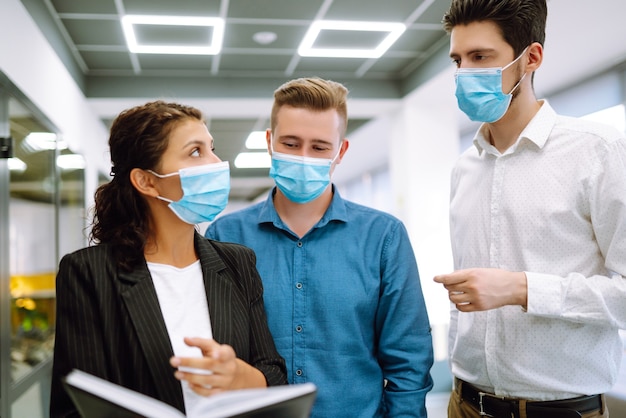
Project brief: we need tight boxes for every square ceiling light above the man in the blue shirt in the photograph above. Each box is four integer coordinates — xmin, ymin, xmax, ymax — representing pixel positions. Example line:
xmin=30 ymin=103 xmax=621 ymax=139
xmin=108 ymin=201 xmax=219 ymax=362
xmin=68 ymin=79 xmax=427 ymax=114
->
xmin=298 ymin=20 xmax=406 ymax=58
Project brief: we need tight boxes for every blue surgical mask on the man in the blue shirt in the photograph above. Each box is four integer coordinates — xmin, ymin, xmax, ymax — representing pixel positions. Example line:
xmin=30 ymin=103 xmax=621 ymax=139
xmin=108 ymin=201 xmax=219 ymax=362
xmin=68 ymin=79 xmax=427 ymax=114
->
xmin=270 ymin=142 xmax=339 ymax=204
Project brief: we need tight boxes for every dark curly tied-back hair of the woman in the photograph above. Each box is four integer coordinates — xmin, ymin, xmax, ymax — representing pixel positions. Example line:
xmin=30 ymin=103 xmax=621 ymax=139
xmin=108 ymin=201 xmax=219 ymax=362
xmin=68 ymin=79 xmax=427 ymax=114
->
xmin=89 ymin=100 xmax=203 ymax=271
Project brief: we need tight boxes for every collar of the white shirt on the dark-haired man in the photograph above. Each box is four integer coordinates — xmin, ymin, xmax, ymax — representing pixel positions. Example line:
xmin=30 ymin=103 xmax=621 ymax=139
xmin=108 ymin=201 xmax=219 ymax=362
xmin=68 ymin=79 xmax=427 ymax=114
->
xmin=474 ymin=99 xmax=557 ymax=155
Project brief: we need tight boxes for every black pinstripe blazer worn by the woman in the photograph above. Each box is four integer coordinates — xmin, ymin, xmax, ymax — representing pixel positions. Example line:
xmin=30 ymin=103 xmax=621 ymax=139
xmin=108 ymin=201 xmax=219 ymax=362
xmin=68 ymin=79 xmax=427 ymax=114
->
xmin=50 ymin=233 xmax=287 ymax=417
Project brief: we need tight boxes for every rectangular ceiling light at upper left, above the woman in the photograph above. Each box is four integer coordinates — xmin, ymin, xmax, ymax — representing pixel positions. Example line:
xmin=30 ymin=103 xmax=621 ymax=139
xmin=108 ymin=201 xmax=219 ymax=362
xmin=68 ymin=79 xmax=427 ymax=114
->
xmin=122 ymin=15 xmax=224 ymax=55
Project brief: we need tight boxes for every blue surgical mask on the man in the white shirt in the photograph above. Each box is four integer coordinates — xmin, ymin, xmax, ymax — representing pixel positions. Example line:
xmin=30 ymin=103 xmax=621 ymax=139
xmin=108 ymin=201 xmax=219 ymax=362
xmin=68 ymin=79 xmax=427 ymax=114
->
xmin=455 ymin=48 xmax=528 ymax=123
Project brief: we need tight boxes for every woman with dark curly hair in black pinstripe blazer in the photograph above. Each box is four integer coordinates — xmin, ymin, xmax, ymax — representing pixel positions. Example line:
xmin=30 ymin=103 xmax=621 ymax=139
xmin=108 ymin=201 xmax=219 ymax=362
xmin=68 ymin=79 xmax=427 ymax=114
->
xmin=50 ymin=101 xmax=286 ymax=417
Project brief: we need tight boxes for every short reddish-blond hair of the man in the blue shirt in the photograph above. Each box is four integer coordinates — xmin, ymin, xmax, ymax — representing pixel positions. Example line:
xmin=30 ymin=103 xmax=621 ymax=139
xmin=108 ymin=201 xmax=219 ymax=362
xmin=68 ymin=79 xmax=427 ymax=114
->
xmin=270 ymin=77 xmax=348 ymax=139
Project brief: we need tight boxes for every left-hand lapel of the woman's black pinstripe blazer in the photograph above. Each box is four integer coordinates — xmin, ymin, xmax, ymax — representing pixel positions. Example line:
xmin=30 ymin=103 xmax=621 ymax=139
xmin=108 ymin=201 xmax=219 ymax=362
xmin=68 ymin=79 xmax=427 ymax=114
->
xmin=119 ymin=263 xmax=183 ymax=407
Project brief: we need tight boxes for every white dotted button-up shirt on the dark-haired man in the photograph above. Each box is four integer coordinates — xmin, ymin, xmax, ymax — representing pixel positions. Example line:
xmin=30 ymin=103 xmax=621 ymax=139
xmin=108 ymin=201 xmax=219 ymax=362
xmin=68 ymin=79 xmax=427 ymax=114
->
xmin=449 ymin=101 xmax=626 ymax=400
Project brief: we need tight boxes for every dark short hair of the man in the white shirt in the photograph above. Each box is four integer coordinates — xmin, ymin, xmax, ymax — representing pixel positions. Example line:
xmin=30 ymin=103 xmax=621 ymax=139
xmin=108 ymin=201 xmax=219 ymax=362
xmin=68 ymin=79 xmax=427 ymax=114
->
xmin=442 ymin=0 xmax=548 ymax=56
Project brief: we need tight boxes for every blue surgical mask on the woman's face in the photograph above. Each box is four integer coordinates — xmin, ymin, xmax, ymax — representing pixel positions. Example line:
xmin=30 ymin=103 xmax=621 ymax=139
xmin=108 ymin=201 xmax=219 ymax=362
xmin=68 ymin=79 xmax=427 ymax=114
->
xmin=148 ymin=161 xmax=230 ymax=224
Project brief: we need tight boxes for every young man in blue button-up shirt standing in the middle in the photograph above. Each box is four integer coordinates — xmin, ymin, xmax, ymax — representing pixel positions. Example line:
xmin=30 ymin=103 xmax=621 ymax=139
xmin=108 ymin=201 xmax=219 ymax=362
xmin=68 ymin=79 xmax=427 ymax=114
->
xmin=206 ymin=78 xmax=433 ymax=418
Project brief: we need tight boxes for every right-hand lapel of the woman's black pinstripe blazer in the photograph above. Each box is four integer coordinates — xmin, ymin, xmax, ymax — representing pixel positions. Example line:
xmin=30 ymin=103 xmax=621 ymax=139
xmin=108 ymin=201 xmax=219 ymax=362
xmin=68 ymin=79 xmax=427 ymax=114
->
xmin=195 ymin=233 xmax=235 ymax=344
